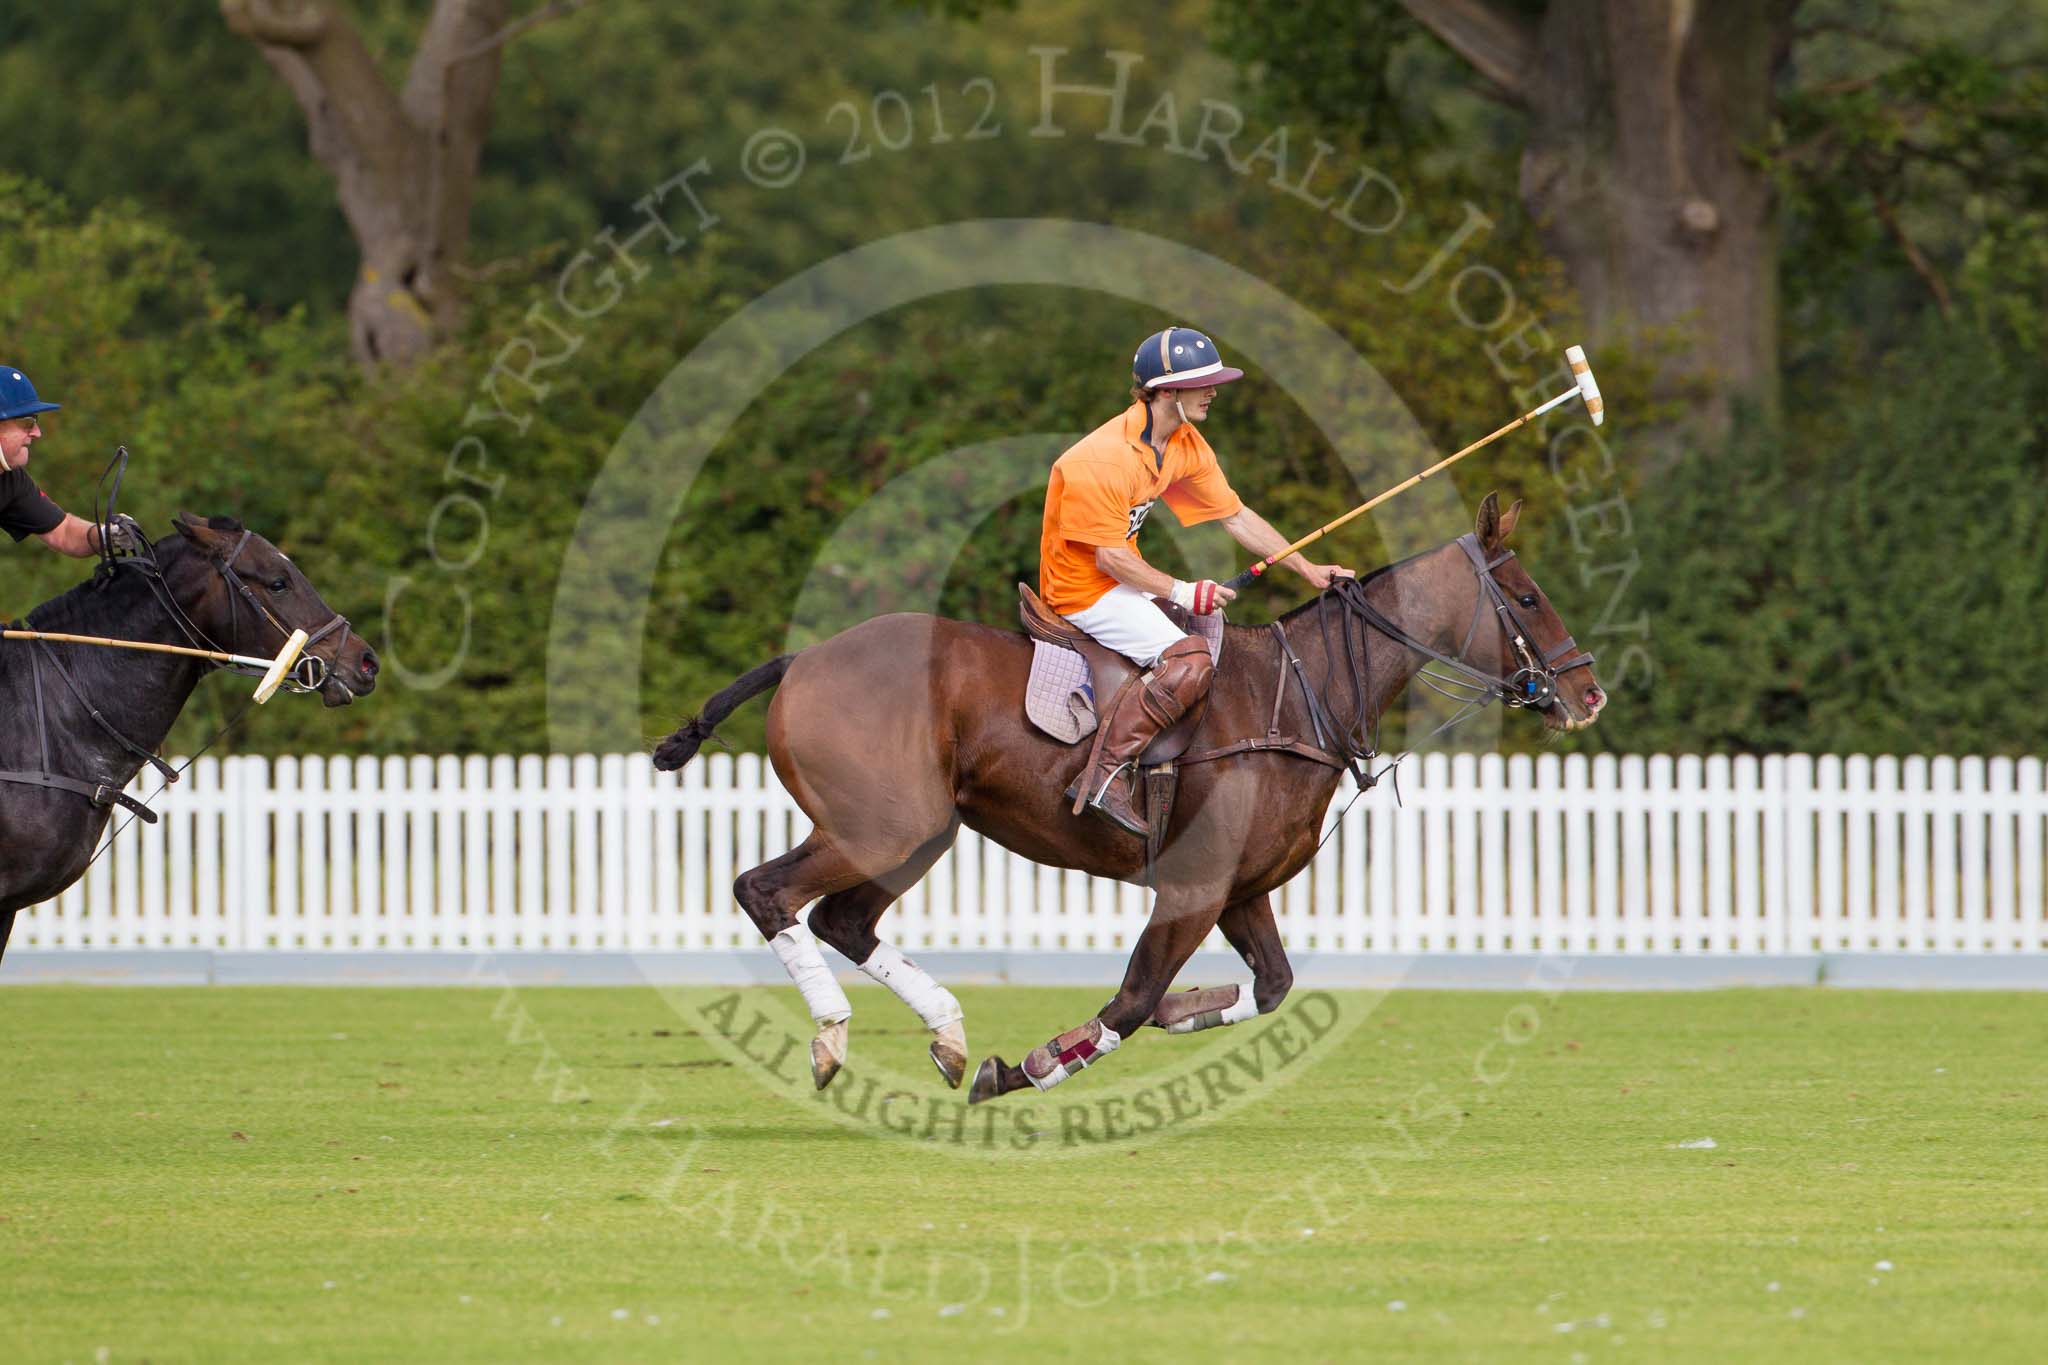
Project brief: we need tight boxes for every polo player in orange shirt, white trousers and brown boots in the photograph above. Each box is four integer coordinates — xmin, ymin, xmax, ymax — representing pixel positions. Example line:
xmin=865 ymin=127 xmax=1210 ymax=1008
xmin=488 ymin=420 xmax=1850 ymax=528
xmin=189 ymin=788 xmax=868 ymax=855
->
xmin=1038 ymin=327 xmax=1352 ymax=839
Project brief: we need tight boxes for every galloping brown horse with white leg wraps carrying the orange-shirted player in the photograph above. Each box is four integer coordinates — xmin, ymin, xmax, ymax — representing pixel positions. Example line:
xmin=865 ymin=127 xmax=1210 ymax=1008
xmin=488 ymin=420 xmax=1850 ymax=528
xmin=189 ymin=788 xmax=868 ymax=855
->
xmin=653 ymin=493 xmax=1606 ymax=1101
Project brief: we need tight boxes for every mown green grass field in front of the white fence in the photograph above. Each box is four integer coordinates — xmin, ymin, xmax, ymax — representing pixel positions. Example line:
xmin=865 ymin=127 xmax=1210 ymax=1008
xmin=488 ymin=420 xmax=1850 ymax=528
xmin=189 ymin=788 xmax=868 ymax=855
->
xmin=0 ymin=988 xmax=2048 ymax=1363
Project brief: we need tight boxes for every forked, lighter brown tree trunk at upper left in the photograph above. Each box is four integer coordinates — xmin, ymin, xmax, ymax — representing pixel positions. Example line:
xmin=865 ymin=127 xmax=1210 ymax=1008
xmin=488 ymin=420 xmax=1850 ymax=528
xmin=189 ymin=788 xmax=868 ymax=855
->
xmin=221 ymin=0 xmax=506 ymax=366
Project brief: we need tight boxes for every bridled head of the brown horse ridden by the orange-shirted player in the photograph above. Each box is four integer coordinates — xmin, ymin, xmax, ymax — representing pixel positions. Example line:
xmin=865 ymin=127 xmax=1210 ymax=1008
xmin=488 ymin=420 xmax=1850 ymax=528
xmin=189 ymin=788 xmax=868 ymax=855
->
xmin=1466 ymin=493 xmax=1608 ymax=731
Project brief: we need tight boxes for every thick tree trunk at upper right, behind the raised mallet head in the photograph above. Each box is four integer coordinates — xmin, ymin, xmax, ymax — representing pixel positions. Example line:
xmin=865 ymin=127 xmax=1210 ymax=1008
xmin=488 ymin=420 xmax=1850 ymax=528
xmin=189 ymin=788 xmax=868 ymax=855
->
xmin=1403 ymin=0 xmax=1798 ymax=430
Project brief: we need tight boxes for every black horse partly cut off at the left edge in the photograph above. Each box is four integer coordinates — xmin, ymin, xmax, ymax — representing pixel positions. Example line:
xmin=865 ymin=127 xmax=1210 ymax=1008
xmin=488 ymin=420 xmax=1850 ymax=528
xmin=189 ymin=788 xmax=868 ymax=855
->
xmin=0 ymin=516 xmax=377 ymax=952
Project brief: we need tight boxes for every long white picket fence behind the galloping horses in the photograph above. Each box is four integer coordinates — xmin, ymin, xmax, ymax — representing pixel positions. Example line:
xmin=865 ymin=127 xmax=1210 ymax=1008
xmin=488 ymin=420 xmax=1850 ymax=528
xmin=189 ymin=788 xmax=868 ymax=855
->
xmin=14 ymin=755 xmax=2048 ymax=954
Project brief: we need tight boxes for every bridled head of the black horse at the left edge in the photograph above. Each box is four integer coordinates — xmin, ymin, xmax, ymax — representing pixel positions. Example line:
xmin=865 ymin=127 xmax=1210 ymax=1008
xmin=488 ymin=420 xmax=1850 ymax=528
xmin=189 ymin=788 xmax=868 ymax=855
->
xmin=174 ymin=512 xmax=377 ymax=706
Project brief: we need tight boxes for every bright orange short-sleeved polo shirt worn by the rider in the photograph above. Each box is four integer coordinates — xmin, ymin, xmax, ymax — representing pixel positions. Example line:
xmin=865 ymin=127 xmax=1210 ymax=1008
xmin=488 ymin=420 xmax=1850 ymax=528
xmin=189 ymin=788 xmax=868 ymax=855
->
xmin=1038 ymin=403 xmax=1245 ymax=614
